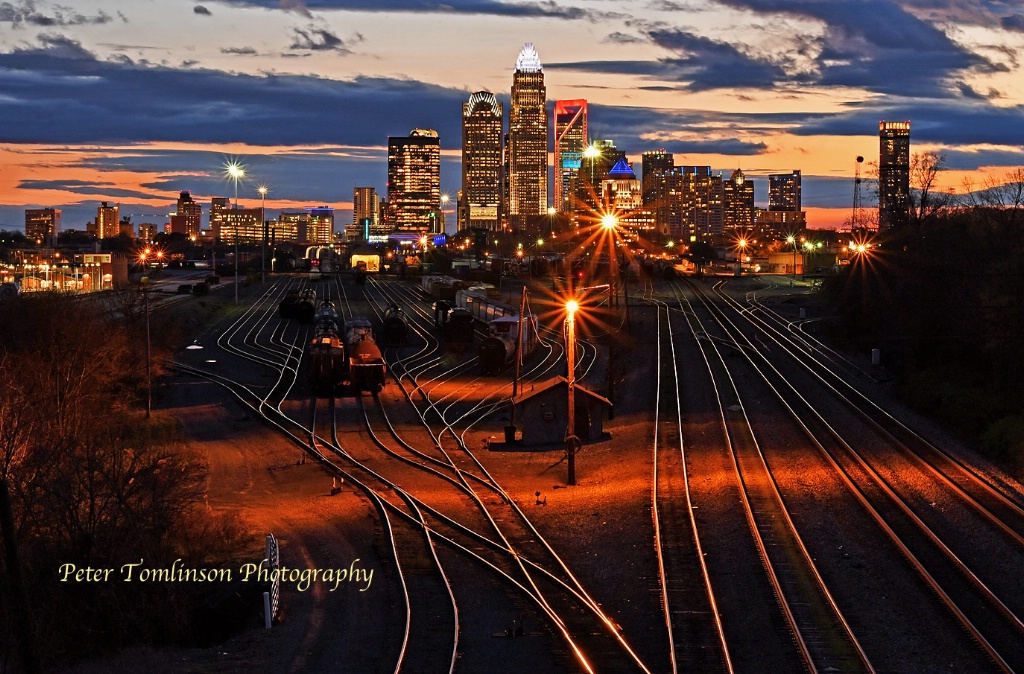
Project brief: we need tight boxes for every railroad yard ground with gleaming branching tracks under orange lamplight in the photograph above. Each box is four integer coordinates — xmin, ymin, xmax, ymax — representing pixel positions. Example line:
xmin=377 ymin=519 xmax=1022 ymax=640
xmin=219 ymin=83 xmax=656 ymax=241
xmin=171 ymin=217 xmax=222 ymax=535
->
xmin=123 ymin=273 xmax=1024 ymax=673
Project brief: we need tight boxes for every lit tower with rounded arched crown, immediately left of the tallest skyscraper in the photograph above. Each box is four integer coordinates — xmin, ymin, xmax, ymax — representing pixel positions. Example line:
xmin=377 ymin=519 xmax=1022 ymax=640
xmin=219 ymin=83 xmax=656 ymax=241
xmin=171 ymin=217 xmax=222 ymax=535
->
xmin=459 ymin=91 xmax=503 ymax=230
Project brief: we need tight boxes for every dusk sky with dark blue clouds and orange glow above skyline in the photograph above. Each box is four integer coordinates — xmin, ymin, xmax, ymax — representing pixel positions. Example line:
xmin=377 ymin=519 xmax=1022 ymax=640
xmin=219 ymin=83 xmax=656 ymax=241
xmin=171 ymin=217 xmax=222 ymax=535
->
xmin=0 ymin=0 xmax=1024 ymax=229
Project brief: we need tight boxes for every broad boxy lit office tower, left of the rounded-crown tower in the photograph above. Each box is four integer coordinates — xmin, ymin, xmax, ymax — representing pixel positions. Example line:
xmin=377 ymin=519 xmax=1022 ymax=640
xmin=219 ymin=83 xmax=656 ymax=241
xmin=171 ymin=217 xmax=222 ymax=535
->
xmin=387 ymin=129 xmax=441 ymax=234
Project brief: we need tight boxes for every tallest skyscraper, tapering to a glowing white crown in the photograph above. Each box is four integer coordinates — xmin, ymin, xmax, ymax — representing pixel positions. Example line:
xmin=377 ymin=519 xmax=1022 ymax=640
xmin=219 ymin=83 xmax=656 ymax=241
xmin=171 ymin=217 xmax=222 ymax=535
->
xmin=508 ymin=43 xmax=548 ymax=229
